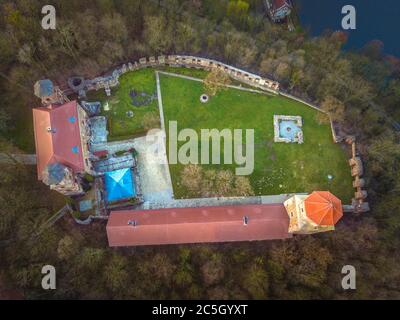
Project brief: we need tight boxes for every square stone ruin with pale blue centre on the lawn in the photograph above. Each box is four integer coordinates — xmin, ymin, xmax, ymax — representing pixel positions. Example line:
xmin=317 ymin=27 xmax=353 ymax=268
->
xmin=274 ymin=115 xmax=303 ymax=144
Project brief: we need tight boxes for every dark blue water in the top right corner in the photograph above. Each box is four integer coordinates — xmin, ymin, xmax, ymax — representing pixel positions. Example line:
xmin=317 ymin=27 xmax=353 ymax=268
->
xmin=292 ymin=0 xmax=400 ymax=57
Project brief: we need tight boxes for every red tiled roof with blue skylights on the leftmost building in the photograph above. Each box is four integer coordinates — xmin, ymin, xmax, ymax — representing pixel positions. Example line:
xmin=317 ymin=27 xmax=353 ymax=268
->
xmin=33 ymin=101 xmax=84 ymax=180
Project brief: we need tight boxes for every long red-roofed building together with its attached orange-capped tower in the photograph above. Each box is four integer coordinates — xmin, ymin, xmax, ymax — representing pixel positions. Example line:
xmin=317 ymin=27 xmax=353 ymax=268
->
xmin=106 ymin=191 xmax=343 ymax=247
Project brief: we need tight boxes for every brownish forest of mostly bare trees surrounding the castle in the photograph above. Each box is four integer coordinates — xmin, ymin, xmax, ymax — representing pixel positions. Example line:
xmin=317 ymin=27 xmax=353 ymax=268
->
xmin=0 ymin=0 xmax=400 ymax=299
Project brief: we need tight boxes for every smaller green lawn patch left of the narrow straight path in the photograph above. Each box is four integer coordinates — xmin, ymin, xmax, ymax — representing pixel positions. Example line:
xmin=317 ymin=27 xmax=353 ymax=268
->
xmin=88 ymin=69 xmax=159 ymax=141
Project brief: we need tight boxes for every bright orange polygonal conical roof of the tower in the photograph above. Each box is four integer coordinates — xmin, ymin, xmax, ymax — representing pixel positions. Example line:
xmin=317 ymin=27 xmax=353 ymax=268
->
xmin=304 ymin=191 xmax=343 ymax=226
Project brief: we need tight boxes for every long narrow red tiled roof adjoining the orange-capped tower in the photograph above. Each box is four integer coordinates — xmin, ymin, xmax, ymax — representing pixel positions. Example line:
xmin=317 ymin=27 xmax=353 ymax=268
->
xmin=107 ymin=204 xmax=291 ymax=247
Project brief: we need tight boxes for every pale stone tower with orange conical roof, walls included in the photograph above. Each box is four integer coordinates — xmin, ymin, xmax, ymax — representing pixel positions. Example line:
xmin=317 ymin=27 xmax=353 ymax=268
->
xmin=284 ymin=191 xmax=343 ymax=234
